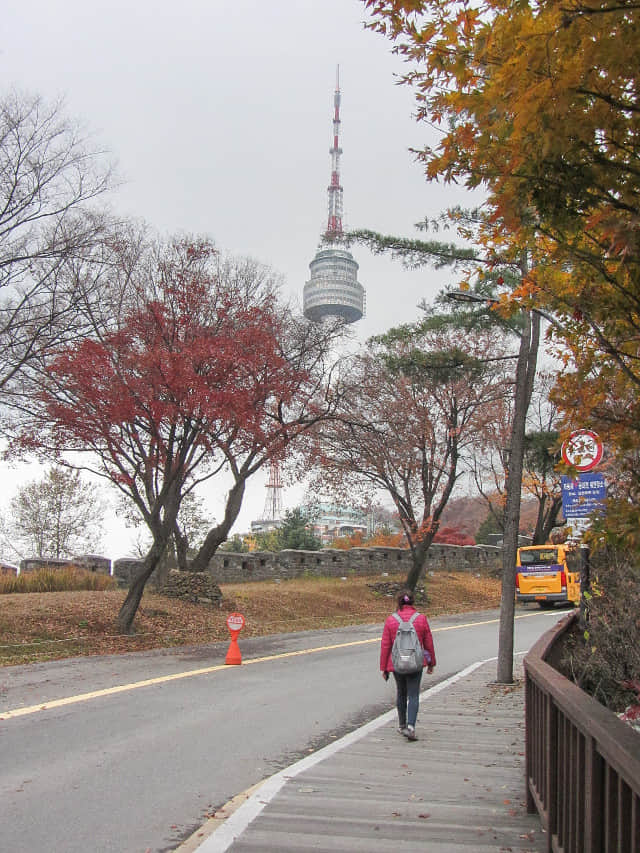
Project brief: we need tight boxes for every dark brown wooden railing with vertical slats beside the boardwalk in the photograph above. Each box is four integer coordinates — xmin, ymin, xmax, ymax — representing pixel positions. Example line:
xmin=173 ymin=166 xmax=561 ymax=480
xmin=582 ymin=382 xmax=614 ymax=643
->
xmin=524 ymin=613 xmax=640 ymax=853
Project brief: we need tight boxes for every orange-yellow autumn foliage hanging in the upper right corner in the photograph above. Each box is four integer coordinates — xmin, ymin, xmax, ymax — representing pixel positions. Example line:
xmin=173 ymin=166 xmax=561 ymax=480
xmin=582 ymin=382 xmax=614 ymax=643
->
xmin=363 ymin=0 xmax=640 ymax=532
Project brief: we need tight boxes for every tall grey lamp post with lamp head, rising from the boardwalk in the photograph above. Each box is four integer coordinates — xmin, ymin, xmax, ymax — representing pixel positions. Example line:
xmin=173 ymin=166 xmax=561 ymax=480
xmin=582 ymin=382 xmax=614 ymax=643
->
xmin=447 ymin=290 xmax=545 ymax=684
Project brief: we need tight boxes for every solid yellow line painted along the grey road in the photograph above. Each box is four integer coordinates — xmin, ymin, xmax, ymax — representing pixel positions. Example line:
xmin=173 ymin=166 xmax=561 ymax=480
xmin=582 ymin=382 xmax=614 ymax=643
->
xmin=0 ymin=613 xmax=549 ymax=720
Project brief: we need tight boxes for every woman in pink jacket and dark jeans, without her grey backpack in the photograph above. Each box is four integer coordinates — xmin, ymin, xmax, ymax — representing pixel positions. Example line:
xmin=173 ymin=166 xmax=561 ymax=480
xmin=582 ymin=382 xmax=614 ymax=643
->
xmin=380 ymin=589 xmax=436 ymax=740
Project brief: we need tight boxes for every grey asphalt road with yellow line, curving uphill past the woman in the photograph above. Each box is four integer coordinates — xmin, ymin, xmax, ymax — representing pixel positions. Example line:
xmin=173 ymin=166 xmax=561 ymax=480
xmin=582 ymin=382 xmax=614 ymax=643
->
xmin=0 ymin=610 xmax=558 ymax=853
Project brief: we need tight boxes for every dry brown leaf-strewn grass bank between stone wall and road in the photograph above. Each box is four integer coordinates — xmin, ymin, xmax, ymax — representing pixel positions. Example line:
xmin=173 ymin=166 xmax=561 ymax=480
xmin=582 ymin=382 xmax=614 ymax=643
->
xmin=0 ymin=572 xmax=500 ymax=666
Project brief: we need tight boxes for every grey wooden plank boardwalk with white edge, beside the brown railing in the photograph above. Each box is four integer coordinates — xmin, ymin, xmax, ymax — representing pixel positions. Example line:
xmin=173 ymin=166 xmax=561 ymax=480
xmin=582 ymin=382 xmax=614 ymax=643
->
xmin=179 ymin=659 xmax=546 ymax=853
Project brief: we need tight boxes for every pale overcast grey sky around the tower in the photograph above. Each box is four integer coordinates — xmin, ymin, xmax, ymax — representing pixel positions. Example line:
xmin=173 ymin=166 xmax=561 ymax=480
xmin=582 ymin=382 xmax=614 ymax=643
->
xmin=0 ymin=0 xmax=476 ymax=556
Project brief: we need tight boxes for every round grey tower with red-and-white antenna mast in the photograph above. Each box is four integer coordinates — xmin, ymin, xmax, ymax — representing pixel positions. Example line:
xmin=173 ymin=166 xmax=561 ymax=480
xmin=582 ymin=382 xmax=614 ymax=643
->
xmin=303 ymin=66 xmax=365 ymax=323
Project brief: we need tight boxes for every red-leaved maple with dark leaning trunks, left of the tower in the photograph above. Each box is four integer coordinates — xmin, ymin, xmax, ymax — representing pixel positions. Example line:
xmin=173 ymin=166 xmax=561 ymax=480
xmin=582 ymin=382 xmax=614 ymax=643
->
xmin=24 ymin=240 xmax=336 ymax=632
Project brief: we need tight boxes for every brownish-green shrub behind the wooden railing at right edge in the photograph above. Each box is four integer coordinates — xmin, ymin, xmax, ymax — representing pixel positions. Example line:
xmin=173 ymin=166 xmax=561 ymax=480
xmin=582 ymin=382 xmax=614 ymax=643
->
xmin=563 ymin=549 xmax=640 ymax=711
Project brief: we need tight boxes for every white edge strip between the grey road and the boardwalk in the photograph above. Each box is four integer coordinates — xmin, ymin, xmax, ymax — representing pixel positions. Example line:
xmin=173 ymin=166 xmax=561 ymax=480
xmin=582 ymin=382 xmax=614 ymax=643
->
xmin=196 ymin=652 xmax=526 ymax=853
